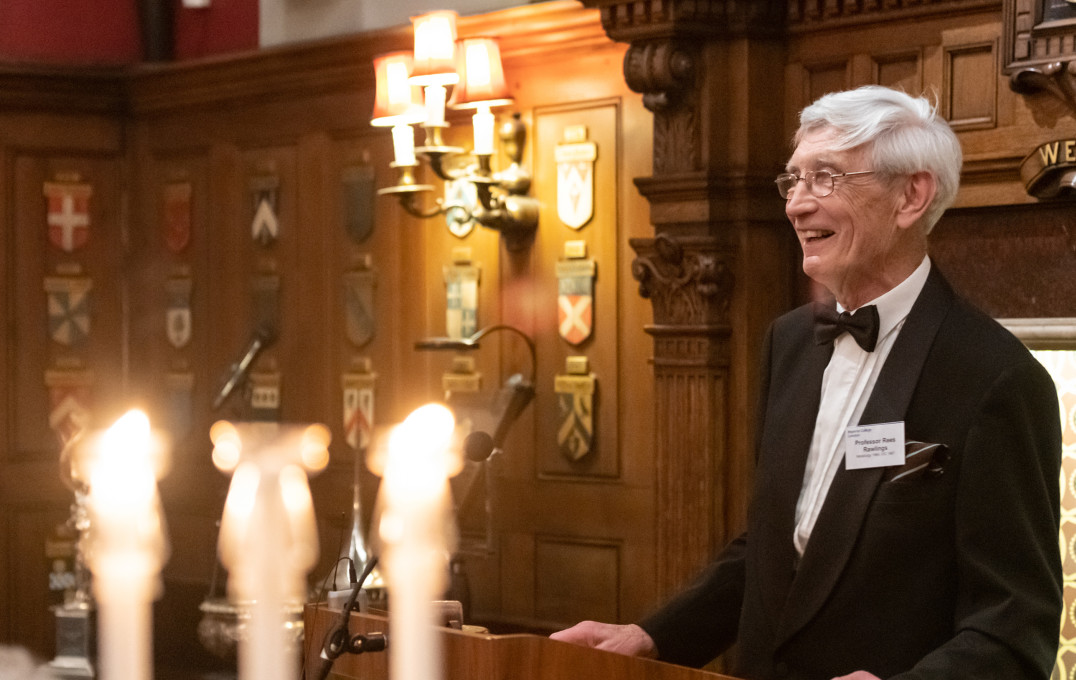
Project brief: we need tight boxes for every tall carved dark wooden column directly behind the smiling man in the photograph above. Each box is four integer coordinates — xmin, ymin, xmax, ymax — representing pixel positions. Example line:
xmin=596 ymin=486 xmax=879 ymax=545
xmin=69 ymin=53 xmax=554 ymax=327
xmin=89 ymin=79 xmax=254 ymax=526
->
xmin=583 ymin=0 xmax=794 ymax=595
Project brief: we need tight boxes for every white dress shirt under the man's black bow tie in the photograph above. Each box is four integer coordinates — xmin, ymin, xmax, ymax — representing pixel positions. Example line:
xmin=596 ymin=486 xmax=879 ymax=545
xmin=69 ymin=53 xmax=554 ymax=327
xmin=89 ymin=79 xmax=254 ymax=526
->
xmin=793 ymin=257 xmax=931 ymax=555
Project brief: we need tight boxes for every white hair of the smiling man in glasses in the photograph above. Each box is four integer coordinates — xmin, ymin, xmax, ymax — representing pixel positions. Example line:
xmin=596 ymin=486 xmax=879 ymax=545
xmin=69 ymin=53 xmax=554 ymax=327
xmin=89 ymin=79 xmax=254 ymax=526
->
xmin=794 ymin=85 xmax=963 ymax=233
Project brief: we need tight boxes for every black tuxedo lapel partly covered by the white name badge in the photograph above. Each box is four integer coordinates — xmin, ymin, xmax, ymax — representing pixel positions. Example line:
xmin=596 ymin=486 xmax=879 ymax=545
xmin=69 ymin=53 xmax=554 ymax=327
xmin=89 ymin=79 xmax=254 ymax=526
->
xmin=778 ymin=266 xmax=953 ymax=643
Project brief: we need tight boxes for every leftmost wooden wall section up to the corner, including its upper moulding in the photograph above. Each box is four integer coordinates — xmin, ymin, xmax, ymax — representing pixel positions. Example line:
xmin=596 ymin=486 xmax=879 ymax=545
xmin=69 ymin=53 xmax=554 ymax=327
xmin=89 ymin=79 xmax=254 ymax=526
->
xmin=0 ymin=68 xmax=123 ymax=656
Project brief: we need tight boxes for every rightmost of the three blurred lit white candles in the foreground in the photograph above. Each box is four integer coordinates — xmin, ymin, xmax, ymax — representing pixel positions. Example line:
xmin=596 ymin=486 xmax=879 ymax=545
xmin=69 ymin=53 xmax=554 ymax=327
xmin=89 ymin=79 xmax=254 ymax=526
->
xmin=379 ymin=403 xmax=455 ymax=680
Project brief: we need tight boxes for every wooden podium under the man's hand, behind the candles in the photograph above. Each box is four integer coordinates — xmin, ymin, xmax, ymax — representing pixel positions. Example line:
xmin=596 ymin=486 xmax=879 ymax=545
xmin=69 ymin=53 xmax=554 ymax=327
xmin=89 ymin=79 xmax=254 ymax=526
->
xmin=303 ymin=605 xmax=734 ymax=680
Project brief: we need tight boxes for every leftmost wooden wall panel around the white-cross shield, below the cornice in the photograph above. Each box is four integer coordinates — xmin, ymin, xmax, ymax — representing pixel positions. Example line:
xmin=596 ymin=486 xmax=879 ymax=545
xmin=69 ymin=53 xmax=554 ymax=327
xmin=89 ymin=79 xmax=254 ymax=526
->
xmin=0 ymin=140 xmax=126 ymax=654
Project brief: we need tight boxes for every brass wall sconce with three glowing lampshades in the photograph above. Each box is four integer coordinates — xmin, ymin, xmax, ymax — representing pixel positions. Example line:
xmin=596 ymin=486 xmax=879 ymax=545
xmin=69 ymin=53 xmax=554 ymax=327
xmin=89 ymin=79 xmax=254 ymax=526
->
xmin=370 ymin=10 xmax=538 ymax=250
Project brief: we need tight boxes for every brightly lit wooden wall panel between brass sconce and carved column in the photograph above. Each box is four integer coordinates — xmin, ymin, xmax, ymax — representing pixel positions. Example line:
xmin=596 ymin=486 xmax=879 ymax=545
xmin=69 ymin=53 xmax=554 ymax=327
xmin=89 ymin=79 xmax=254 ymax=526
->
xmin=475 ymin=13 xmax=655 ymax=628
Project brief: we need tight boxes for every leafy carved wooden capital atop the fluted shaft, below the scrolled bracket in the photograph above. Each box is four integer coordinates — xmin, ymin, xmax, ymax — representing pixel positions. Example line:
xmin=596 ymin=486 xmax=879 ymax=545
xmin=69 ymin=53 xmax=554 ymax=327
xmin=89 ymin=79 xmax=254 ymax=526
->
xmin=631 ymin=233 xmax=735 ymax=326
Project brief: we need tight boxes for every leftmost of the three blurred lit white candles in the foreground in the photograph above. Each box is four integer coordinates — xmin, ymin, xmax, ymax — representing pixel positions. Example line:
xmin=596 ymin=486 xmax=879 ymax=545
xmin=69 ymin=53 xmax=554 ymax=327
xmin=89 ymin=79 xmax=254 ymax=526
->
xmin=86 ymin=411 xmax=168 ymax=680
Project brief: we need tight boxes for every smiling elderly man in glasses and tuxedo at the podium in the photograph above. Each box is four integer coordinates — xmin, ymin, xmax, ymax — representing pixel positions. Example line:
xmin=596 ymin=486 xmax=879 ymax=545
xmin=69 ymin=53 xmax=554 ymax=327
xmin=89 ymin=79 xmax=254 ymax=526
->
xmin=553 ymin=86 xmax=1062 ymax=680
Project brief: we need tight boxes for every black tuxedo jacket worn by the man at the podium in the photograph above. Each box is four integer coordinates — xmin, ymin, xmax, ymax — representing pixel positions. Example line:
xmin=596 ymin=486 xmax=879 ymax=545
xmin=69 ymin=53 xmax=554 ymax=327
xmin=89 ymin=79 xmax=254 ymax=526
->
xmin=640 ymin=268 xmax=1062 ymax=680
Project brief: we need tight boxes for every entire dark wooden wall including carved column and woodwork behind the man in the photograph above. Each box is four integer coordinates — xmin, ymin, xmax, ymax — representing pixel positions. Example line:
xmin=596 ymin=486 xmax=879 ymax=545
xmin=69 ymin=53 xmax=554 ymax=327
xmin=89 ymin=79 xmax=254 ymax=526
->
xmin=0 ymin=0 xmax=1076 ymax=667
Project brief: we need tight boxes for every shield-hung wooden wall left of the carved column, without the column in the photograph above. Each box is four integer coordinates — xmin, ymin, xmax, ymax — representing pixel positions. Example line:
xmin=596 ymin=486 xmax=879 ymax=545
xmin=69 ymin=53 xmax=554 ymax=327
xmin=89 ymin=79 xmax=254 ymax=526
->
xmin=0 ymin=2 xmax=656 ymax=668
